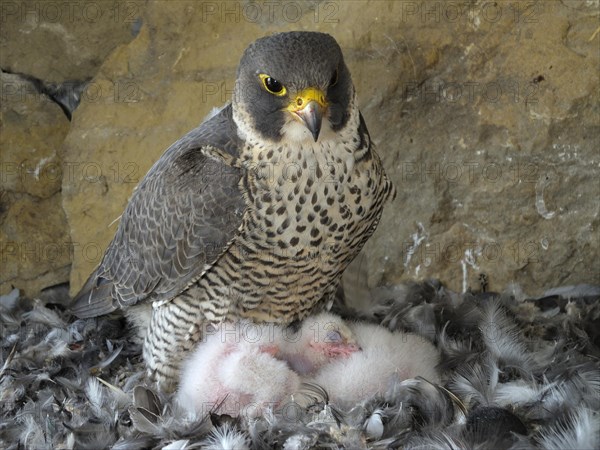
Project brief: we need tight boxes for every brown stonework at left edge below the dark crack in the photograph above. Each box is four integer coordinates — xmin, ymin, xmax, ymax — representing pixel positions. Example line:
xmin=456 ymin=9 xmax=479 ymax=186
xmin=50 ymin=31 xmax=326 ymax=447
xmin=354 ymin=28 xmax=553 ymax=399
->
xmin=0 ymin=73 xmax=71 ymax=295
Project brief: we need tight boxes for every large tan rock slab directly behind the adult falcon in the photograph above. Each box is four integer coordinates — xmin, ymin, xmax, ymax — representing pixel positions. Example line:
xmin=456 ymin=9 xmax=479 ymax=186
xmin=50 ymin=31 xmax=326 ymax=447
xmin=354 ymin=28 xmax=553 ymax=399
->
xmin=0 ymin=0 xmax=600 ymax=294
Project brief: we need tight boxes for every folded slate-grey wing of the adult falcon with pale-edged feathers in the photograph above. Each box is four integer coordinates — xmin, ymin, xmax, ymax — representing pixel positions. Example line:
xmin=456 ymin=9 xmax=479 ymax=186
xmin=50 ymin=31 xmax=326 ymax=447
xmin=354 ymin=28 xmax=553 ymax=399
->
xmin=71 ymin=106 xmax=245 ymax=318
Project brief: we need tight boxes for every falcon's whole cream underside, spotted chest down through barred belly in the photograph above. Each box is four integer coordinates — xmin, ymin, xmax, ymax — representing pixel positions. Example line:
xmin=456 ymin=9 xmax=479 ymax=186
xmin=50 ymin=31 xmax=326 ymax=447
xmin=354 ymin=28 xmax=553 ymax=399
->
xmin=216 ymin=139 xmax=382 ymax=322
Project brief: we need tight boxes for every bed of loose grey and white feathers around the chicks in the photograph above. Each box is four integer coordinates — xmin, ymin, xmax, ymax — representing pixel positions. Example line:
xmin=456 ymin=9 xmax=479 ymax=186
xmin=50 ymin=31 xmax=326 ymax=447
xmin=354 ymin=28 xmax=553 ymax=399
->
xmin=0 ymin=281 xmax=600 ymax=449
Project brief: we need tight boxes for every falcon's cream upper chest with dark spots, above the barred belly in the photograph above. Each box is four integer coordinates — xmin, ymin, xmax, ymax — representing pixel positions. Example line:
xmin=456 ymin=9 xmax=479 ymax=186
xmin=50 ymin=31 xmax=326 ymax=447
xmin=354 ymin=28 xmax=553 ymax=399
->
xmin=246 ymin=141 xmax=370 ymax=260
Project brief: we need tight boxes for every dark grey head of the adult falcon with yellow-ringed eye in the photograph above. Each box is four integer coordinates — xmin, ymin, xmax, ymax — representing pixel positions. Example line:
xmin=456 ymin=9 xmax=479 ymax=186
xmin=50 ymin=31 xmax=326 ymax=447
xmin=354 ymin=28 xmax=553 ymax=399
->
xmin=233 ymin=31 xmax=354 ymax=141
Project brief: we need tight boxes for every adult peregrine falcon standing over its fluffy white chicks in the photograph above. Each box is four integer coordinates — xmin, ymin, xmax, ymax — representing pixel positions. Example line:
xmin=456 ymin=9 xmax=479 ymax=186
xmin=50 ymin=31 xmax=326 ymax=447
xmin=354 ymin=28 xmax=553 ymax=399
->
xmin=72 ymin=32 xmax=395 ymax=390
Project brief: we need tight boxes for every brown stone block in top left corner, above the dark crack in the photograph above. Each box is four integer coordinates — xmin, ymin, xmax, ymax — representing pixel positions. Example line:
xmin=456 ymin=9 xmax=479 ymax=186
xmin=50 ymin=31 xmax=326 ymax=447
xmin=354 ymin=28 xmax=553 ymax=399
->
xmin=0 ymin=0 xmax=143 ymax=83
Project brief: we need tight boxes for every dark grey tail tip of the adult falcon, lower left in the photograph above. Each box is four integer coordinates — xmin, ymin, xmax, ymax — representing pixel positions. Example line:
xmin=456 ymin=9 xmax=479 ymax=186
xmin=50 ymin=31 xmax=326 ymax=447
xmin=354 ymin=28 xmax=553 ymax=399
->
xmin=71 ymin=272 xmax=117 ymax=319
